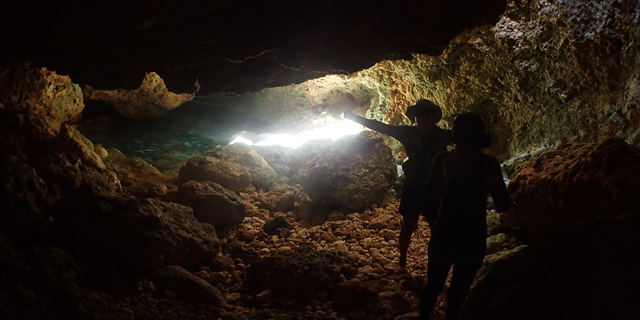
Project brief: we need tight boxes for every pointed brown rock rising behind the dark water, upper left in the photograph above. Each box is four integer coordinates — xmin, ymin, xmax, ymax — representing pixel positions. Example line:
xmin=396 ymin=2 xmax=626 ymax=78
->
xmin=82 ymin=72 xmax=195 ymax=118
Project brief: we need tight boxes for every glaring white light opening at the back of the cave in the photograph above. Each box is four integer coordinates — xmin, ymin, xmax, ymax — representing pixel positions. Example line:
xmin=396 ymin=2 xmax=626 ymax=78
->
xmin=229 ymin=121 xmax=364 ymax=148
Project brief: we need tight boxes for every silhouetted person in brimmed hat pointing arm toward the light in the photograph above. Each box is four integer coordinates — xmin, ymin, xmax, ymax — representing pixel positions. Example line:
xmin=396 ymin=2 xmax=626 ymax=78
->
xmin=344 ymin=99 xmax=451 ymax=273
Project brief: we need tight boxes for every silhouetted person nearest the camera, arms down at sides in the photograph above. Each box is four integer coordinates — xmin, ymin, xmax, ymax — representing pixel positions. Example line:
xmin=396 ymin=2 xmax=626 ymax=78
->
xmin=420 ymin=113 xmax=510 ymax=319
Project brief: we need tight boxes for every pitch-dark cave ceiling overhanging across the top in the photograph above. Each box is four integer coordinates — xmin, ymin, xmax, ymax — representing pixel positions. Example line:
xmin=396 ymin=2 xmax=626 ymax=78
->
xmin=0 ymin=0 xmax=506 ymax=95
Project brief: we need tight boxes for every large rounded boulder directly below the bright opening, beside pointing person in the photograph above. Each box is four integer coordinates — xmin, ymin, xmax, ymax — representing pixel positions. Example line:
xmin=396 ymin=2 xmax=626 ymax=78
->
xmin=300 ymin=131 xmax=395 ymax=210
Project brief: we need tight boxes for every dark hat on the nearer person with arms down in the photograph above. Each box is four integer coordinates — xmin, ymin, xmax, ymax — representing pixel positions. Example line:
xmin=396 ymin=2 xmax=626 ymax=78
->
xmin=451 ymin=112 xmax=491 ymax=148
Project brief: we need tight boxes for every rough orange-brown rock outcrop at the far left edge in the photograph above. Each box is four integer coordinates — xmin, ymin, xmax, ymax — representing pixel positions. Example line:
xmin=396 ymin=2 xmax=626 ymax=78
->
xmin=0 ymin=68 xmax=84 ymax=141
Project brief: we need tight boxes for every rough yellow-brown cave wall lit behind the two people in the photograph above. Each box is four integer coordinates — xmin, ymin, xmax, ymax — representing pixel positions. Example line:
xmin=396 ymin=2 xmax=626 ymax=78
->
xmin=216 ymin=1 xmax=640 ymax=160
